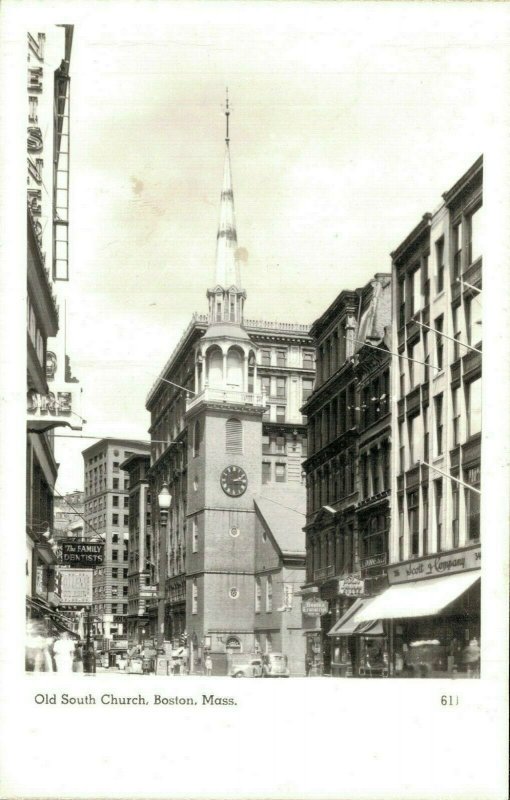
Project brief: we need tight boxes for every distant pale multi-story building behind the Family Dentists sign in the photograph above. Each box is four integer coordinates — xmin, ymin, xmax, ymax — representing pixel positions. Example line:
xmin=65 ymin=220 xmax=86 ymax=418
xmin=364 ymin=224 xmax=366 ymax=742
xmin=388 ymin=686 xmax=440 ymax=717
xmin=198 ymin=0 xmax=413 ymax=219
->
xmin=83 ymin=439 xmax=150 ymax=650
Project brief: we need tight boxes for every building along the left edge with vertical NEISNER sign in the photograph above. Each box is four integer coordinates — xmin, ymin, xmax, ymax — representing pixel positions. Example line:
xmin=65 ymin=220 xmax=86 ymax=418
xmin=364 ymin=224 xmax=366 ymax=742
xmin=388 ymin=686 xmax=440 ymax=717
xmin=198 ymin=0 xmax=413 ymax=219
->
xmin=25 ymin=25 xmax=81 ymax=644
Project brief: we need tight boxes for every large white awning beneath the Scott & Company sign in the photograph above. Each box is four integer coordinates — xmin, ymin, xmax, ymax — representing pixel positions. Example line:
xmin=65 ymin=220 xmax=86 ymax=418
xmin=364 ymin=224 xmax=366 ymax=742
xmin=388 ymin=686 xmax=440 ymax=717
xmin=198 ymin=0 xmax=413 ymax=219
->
xmin=352 ymin=571 xmax=480 ymax=622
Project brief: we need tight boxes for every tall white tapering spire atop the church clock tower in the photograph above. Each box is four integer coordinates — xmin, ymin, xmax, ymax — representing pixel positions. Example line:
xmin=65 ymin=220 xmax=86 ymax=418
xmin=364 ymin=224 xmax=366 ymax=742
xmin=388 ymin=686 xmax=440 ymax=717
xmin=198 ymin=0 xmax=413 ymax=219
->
xmin=215 ymin=89 xmax=241 ymax=289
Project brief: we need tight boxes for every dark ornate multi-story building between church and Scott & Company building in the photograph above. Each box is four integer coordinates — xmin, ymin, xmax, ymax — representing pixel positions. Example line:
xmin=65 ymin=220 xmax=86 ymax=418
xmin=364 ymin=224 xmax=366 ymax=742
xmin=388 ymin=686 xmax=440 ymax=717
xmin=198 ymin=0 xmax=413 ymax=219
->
xmin=302 ymin=273 xmax=391 ymax=676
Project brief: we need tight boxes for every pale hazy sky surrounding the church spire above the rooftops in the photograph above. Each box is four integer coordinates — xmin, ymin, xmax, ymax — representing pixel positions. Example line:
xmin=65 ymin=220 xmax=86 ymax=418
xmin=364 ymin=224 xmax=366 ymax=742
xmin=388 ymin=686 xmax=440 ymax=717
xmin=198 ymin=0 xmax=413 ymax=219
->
xmin=42 ymin=2 xmax=506 ymax=492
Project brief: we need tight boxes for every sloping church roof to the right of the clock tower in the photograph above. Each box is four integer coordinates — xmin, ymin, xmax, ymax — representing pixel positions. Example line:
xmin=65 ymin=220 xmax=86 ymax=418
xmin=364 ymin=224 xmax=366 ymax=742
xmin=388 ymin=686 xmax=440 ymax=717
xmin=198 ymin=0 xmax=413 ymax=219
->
xmin=254 ymin=484 xmax=306 ymax=556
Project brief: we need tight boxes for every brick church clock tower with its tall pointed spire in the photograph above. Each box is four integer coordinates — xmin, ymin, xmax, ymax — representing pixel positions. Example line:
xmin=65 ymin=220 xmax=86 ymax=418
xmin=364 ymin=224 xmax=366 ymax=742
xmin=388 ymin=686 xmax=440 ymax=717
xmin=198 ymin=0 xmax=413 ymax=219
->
xmin=186 ymin=95 xmax=266 ymax=668
